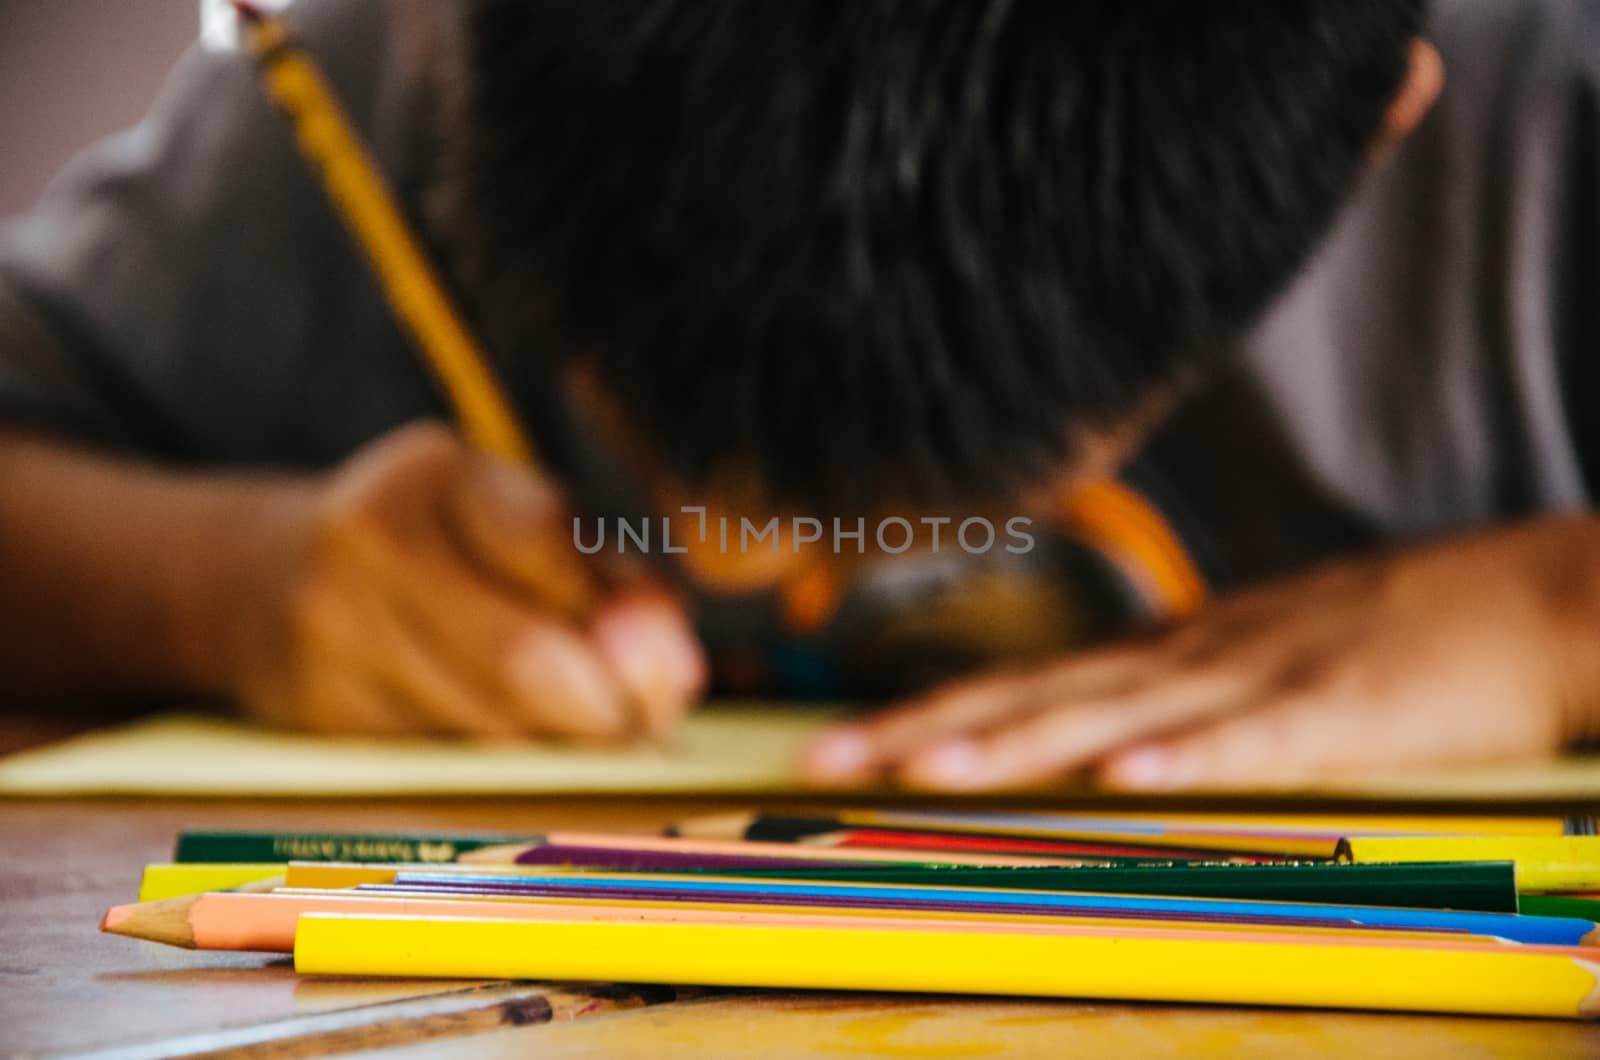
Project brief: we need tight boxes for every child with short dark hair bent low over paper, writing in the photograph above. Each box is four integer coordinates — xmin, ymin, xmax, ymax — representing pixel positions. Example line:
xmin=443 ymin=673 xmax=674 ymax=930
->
xmin=0 ymin=0 xmax=1600 ymax=788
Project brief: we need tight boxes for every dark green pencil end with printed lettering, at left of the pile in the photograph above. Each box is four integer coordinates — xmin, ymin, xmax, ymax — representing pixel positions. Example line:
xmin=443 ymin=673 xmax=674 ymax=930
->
xmin=173 ymin=829 xmax=524 ymax=865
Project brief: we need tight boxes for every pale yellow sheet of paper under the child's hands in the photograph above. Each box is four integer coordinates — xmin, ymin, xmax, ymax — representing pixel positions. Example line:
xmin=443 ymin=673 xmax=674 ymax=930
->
xmin=0 ymin=703 xmax=1600 ymax=804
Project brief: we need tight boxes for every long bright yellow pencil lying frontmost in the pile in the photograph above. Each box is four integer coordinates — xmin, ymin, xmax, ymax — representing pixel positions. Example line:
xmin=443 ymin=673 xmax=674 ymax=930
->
xmin=294 ymin=914 xmax=1600 ymax=1018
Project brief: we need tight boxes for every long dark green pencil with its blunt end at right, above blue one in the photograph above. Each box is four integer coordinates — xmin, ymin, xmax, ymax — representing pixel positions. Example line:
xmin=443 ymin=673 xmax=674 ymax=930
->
xmin=448 ymin=858 xmax=1517 ymax=913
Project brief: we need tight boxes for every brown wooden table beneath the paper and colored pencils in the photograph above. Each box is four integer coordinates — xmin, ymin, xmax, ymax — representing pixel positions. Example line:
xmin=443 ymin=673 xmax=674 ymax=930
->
xmin=0 ymin=717 xmax=1600 ymax=1060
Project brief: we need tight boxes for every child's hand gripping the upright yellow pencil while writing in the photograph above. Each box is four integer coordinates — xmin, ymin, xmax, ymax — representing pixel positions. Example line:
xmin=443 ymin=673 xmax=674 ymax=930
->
xmin=224 ymin=426 xmax=704 ymax=737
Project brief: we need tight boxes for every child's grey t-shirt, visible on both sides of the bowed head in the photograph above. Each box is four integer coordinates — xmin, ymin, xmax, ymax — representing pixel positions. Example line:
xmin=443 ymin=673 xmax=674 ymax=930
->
xmin=0 ymin=0 xmax=1600 ymax=575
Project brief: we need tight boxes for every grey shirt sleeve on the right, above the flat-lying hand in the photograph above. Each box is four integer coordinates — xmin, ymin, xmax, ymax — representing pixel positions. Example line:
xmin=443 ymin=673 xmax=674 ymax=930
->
xmin=1248 ymin=0 xmax=1600 ymax=538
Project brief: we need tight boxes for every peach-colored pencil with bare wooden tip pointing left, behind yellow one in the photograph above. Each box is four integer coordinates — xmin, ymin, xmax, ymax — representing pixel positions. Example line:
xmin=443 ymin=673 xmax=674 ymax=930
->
xmin=101 ymin=892 xmax=1484 ymax=953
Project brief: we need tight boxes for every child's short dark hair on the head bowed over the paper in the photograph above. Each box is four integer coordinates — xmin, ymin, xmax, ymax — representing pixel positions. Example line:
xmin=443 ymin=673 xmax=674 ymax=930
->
xmin=456 ymin=0 xmax=1424 ymax=508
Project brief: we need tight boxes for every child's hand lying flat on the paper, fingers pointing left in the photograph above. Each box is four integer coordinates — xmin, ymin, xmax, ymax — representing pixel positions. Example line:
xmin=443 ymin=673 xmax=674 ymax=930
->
xmin=806 ymin=519 xmax=1600 ymax=789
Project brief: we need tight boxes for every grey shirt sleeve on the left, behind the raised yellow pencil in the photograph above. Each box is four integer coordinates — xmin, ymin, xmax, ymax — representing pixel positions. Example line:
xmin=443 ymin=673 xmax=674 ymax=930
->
xmin=0 ymin=0 xmax=440 ymax=466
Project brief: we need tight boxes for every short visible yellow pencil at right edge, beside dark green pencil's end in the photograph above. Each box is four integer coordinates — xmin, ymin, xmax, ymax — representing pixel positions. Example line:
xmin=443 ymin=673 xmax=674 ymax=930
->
xmin=1338 ymin=836 xmax=1600 ymax=892
